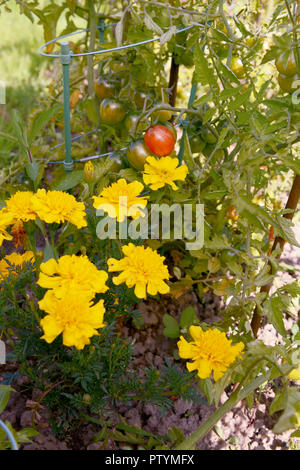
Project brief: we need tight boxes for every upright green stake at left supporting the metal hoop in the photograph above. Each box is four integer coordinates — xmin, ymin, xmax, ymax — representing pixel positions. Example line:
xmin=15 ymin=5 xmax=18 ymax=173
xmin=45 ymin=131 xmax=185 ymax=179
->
xmin=60 ymin=42 xmax=74 ymax=171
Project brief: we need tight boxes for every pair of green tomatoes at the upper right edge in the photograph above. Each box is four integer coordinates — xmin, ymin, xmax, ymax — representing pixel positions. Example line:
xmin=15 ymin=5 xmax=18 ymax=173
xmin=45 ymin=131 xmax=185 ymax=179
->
xmin=275 ymin=50 xmax=299 ymax=93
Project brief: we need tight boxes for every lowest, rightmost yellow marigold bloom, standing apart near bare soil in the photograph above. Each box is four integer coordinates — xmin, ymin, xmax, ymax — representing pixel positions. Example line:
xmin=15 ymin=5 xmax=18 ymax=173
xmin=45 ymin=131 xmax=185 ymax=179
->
xmin=177 ymin=326 xmax=244 ymax=381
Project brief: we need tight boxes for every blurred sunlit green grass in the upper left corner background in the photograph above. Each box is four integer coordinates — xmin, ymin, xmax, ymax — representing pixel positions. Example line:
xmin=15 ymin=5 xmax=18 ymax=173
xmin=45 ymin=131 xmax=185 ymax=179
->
xmin=0 ymin=1 xmax=47 ymax=167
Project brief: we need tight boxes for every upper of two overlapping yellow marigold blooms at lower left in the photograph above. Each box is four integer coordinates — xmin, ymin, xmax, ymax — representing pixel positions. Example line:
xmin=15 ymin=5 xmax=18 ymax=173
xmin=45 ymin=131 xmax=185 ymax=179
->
xmin=37 ymin=255 xmax=108 ymax=299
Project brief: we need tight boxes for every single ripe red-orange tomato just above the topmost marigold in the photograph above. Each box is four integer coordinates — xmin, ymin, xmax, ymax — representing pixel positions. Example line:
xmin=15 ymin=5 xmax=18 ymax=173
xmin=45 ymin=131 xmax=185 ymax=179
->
xmin=144 ymin=124 xmax=175 ymax=157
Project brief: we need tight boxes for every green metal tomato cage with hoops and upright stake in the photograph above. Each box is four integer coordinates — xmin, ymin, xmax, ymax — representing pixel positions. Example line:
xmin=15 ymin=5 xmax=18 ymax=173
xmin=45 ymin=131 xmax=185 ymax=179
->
xmin=39 ymin=22 xmax=195 ymax=172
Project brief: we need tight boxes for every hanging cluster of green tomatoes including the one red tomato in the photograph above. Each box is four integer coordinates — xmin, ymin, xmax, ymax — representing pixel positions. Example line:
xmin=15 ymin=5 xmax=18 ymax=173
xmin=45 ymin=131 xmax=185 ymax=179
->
xmin=94 ymin=53 xmax=177 ymax=170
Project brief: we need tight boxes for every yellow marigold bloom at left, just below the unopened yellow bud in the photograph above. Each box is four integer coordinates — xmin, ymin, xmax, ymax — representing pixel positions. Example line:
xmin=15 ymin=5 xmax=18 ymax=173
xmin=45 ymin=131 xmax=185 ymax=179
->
xmin=32 ymin=189 xmax=87 ymax=228
